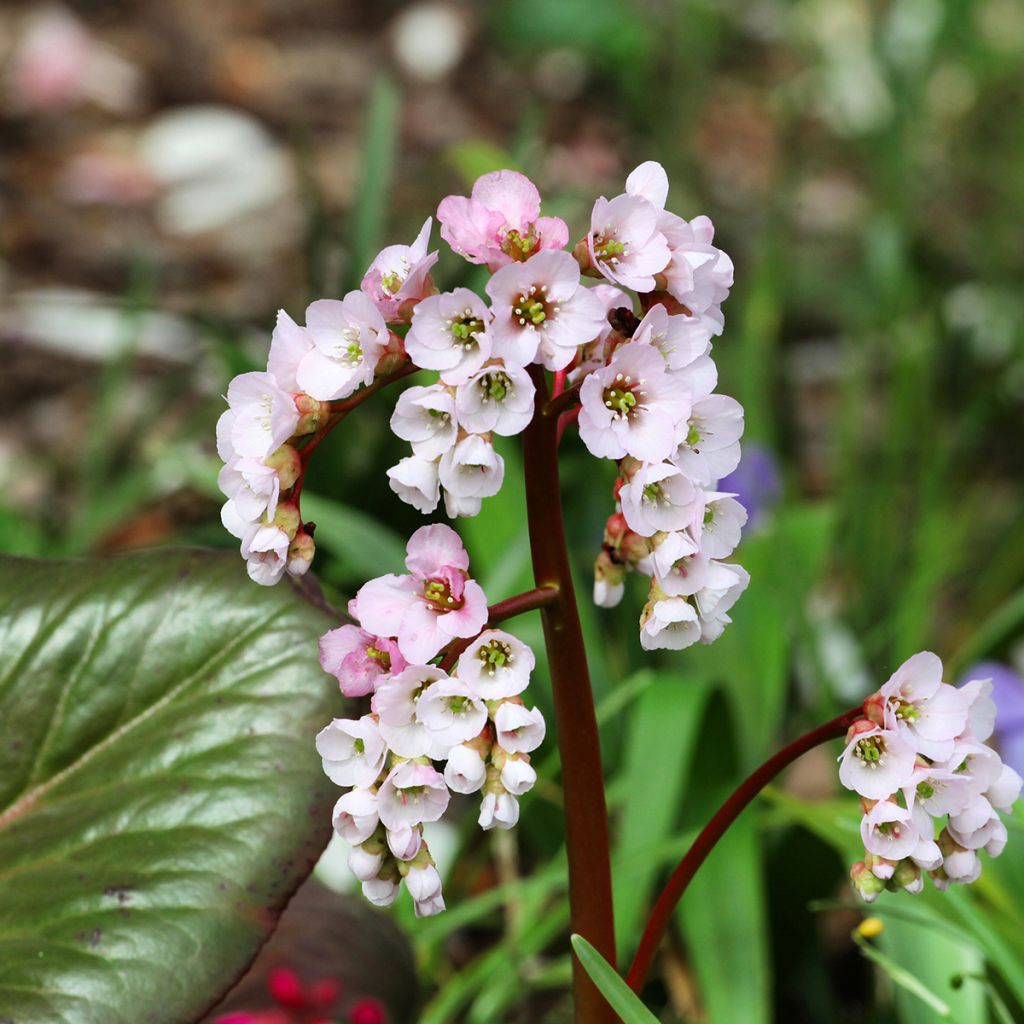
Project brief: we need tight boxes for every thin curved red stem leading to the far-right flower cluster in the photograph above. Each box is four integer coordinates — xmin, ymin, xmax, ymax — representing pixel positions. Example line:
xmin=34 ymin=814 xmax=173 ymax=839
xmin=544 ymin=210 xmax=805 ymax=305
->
xmin=626 ymin=708 xmax=863 ymax=992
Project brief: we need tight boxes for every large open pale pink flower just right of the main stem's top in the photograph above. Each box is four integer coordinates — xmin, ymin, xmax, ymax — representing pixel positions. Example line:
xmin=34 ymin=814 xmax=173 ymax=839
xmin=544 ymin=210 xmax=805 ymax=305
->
xmin=580 ymin=344 xmax=690 ymax=460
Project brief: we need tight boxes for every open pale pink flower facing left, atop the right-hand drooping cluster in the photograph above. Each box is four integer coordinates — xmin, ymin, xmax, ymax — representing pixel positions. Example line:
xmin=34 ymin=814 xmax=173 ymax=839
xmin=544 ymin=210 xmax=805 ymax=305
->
xmin=587 ymin=194 xmax=670 ymax=292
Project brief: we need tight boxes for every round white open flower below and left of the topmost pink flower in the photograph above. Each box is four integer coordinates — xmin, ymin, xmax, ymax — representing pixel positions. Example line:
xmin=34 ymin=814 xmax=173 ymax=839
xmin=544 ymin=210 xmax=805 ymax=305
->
xmin=406 ymin=288 xmax=492 ymax=384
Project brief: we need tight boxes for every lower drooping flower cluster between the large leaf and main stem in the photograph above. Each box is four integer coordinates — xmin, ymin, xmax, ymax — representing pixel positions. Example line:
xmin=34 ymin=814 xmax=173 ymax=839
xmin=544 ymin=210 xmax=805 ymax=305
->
xmin=316 ymin=524 xmax=545 ymax=915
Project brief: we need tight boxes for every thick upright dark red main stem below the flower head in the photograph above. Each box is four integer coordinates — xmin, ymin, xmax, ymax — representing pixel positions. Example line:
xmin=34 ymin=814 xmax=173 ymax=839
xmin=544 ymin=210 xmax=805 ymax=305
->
xmin=523 ymin=366 xmax=617 ymax=1024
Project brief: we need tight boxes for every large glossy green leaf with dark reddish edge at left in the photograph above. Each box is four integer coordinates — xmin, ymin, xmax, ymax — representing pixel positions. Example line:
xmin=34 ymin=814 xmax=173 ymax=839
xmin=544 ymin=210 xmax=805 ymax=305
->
xmin=0 ymin=551 xmax=333 ymax=1024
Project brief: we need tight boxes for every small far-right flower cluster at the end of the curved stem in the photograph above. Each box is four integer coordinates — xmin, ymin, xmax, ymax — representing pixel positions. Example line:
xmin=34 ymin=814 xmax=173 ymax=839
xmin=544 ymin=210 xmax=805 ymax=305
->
xmin=840 ymin=651 xmax=1021 ymax=902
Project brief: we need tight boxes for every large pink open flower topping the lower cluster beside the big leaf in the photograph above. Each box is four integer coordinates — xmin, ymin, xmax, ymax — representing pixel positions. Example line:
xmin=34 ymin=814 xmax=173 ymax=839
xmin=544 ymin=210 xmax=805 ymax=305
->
xmin=353 ymin=523 xmax=487 ymax=665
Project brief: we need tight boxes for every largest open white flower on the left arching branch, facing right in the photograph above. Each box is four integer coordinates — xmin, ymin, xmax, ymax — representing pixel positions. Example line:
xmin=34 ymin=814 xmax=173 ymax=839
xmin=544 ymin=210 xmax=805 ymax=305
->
xmin=296 ymin=291 xmax=388 ymax=401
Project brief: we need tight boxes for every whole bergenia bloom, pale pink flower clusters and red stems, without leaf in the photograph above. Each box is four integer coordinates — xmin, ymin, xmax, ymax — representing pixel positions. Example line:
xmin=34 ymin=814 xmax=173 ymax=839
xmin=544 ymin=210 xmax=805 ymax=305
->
xmin=217 ymin=162 xmax=1021 ymax=1022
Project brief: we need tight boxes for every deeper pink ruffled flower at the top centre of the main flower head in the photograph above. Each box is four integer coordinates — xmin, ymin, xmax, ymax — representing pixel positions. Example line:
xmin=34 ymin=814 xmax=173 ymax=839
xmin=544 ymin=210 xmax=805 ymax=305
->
xmin=437 ymin=171 xmax=569 ymax=271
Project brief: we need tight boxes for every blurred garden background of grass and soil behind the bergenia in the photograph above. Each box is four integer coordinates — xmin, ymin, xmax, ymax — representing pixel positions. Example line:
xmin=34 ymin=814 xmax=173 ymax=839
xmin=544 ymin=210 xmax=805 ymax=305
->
xmin=0 ymin=0 xmax=1024 ymax=1024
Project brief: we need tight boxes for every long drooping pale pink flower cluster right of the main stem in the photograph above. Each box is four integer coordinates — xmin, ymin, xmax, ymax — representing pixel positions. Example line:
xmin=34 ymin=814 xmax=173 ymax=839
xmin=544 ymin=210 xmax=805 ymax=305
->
xmin=580 ymin=164 xmax=750 ymax=650
